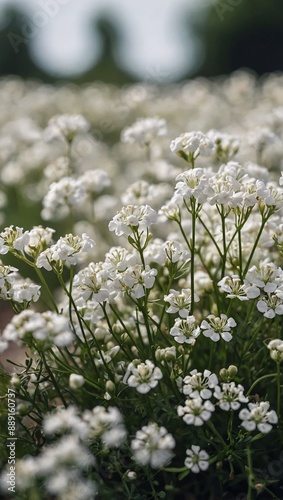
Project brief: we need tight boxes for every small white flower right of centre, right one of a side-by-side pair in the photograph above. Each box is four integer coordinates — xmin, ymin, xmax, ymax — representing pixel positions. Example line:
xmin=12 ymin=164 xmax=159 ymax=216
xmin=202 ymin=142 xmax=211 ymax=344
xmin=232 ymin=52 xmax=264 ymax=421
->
xmin=200 ymin=314 xmax=237 ymax=342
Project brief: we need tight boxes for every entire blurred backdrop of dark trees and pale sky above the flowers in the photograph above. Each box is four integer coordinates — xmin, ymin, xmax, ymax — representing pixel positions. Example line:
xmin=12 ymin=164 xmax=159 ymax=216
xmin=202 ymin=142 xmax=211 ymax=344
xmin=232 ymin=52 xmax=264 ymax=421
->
xmin=0 ymin=0 xmax=283 ymax=85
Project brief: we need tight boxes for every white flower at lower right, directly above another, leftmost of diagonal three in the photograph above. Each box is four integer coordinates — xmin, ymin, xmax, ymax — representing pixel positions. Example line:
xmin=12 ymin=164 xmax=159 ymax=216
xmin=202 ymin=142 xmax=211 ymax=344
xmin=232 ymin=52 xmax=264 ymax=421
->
xmin=183 ymin=370 xmax=221 ymax=399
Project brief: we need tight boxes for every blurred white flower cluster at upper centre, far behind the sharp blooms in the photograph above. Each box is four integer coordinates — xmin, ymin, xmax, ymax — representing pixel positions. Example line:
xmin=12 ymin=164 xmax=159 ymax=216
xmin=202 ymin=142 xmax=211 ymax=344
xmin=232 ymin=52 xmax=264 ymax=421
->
xmin=121 ymin=117 xmax=167 ymax=146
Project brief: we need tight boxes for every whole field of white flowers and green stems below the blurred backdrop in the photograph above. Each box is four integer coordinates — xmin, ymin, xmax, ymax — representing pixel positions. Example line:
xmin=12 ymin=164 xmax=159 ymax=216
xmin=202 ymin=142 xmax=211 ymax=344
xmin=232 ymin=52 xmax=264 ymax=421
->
xmin=0 ymin=71 xmax=283 ymax=500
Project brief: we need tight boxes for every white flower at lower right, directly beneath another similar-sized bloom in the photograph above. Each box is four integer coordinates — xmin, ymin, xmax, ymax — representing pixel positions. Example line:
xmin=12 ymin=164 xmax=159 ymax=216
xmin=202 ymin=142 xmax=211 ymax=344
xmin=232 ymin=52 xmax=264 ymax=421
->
xmin=177 ymin=397 xmax=215 ymax=427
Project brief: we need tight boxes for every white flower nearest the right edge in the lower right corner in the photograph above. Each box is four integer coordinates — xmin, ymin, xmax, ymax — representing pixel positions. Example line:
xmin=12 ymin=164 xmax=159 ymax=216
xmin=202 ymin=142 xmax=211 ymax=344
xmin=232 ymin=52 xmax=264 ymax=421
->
xmin=239 ymin=401 xmax=278 ymax=434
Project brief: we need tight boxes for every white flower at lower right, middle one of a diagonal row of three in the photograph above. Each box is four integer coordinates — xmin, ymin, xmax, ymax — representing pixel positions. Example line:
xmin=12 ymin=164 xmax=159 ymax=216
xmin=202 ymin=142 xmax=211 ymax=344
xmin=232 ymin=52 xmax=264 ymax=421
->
xmin=213 ymin=382 xmax=249 ymax=411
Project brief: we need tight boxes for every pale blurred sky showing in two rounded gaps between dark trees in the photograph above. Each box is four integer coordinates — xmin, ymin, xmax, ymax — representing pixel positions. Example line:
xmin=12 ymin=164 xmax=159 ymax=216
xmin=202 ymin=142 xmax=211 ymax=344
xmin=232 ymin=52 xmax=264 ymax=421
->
xmin=0 ymin=0 xmax=209 ymax=81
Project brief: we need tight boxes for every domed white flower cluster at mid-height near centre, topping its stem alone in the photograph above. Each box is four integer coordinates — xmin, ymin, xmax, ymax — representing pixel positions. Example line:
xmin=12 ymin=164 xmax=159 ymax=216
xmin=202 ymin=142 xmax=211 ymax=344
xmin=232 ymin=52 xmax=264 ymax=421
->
xmin=108 ymin=205 xmax=157 ymax=236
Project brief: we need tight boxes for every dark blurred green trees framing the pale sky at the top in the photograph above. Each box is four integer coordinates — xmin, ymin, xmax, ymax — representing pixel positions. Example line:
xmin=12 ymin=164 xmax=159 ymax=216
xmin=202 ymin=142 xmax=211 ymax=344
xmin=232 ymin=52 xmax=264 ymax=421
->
xmin=0 ymin=0 xmax=283 ymax=85
